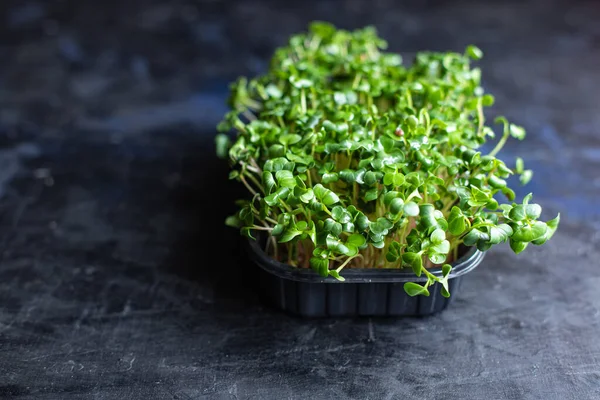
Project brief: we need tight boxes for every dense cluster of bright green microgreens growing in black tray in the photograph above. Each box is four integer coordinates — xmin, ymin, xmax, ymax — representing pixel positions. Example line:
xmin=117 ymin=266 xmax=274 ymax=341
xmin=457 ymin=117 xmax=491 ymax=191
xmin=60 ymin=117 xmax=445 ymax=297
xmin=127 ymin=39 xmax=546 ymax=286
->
xmin=216 ymin=22 xmax=559 ymax=296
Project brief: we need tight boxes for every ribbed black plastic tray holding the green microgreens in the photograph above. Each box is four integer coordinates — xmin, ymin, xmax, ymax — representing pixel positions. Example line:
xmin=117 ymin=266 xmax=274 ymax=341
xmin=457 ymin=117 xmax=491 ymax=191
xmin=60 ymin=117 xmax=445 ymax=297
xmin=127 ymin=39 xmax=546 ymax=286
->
xmin=247 ymin=240 xmax=484 ymax=317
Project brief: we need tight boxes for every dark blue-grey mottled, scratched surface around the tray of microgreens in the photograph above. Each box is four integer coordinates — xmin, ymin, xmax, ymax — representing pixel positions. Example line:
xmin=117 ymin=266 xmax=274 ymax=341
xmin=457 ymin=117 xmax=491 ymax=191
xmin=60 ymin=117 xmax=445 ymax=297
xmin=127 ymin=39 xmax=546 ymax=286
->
xmin=0 ymin=0 xmax=600 ymax=400
